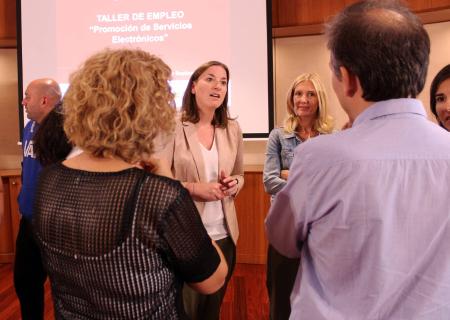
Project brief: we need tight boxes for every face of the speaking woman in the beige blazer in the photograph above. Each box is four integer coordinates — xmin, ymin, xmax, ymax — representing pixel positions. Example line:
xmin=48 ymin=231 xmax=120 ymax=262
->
xmin=191 ymin=66 xmax=228 ymax=113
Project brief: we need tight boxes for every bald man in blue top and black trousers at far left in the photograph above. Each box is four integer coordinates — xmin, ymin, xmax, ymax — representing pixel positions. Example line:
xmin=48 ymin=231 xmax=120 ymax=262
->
xmin=14 ymin=79 xmax=61 ymax=320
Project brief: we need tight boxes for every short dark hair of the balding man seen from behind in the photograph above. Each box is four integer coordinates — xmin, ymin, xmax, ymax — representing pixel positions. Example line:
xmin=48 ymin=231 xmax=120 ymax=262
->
xmin=327 ymin=0 xmax=430 ymax=101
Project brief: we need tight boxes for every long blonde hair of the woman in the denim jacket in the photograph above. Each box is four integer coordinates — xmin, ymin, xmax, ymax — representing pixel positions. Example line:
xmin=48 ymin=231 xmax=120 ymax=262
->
xmin=284 ymin=73 xmax=334 ymax=133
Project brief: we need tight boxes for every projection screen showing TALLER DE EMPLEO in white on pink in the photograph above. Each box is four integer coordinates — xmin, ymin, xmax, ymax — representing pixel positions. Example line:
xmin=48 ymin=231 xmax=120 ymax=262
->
xmin=17 ymin=0 xmax=273 ymax=138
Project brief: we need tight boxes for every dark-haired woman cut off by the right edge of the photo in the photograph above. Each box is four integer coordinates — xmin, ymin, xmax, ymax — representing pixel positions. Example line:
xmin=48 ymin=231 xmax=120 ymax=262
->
xmin=430 ymin=64 xmax=450 ymax=131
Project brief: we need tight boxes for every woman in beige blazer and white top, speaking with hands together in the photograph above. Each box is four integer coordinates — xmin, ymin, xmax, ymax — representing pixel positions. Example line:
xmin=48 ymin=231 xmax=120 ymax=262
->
xmin=157 ymin=61 xmax=244 ymax=320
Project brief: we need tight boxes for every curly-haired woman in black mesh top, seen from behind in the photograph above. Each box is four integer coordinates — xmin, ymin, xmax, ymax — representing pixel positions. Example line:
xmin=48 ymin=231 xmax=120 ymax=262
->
xmin=34 ymin=49 xmax=228 ymax=319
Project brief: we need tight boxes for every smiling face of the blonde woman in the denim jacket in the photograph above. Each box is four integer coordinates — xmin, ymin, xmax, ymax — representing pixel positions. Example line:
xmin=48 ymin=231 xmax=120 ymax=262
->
xmin=292 ymin=80 xmax=319 ymax=117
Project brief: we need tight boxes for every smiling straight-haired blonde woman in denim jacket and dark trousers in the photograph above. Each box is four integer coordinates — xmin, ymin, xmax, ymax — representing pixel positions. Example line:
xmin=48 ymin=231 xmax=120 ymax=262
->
xmin=263 ymin=73 xmax=333 ymax=320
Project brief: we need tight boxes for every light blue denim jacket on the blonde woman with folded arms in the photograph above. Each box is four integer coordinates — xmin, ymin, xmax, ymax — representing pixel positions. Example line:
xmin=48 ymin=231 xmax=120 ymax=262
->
xmin=263 ymin=128 xmax=303 ymax=198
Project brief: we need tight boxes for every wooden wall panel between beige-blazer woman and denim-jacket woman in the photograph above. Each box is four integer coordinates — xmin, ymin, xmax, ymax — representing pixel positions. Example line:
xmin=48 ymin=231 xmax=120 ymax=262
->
xmin=236 ymin=172 xmax=270 ymax=264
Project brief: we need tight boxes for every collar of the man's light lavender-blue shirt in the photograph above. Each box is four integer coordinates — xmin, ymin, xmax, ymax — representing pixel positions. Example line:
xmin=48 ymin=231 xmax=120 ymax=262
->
xmin=352 ymin=98 xmax=427 ymax=127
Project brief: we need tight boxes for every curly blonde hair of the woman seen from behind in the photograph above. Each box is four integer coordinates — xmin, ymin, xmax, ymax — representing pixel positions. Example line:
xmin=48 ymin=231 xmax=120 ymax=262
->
xmin=63 ymin=49 xmax=175 ymax=163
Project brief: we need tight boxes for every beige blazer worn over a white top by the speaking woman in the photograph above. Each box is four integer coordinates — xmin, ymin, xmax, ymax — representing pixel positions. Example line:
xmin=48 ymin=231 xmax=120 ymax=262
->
xmin=157 ymin=119 xmax=244 ymax=244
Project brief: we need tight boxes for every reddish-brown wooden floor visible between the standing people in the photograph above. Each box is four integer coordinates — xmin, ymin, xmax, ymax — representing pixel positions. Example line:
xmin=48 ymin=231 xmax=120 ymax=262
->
xmin=0 ymin=264 xmax=269 ymax=320
